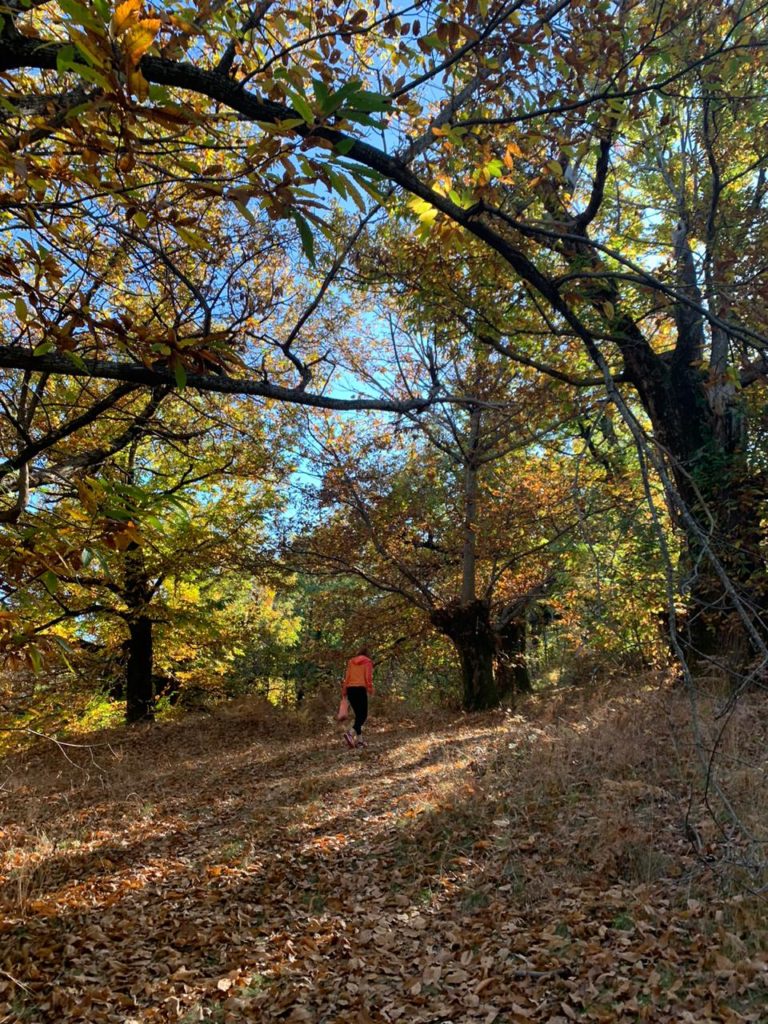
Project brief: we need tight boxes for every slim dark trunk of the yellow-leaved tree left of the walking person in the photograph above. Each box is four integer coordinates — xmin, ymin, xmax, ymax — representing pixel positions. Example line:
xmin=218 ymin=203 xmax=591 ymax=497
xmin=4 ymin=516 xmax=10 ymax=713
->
xmin=124 ymin=543 xmax=155 ymax=722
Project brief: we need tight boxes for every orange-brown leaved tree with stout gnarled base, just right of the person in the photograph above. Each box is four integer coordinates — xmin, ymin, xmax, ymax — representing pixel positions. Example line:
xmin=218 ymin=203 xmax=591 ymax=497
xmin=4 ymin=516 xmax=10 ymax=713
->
xmin=289 ymin=339 xmax=589 ymax=710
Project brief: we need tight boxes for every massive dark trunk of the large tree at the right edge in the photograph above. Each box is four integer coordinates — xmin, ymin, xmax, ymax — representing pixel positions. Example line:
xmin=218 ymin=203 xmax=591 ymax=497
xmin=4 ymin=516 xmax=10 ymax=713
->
xmin=623 ymin=331 xmax=766 ymax=673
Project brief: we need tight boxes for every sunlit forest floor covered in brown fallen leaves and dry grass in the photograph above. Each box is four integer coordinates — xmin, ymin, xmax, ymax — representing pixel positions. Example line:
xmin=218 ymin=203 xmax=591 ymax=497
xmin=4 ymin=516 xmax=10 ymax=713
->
xmin=0 ymin=684 xmax=768 ymax=1024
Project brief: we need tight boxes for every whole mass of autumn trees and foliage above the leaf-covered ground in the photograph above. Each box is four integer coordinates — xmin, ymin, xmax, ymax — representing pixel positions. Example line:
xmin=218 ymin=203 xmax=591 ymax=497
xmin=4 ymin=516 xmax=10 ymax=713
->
xmin=0 ymin=0 xmax=768 ymax=720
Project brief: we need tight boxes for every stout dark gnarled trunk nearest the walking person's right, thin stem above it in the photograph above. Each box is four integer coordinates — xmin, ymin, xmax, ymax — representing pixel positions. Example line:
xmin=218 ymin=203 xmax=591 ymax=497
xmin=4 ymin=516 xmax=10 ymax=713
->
xmin=431 ymin=601 xmax=501 ymax=711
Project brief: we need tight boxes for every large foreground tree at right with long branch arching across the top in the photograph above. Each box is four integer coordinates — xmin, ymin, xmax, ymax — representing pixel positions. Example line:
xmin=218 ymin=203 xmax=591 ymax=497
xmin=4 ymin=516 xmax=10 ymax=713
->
xmin=0 ymin=0 xmax=766 ymax=662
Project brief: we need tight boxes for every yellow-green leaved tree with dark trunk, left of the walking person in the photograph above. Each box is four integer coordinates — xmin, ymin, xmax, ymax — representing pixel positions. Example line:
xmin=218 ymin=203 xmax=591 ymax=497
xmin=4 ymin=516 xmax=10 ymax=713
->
xmin=4 ymin=389 xmax=285 ymax=721
